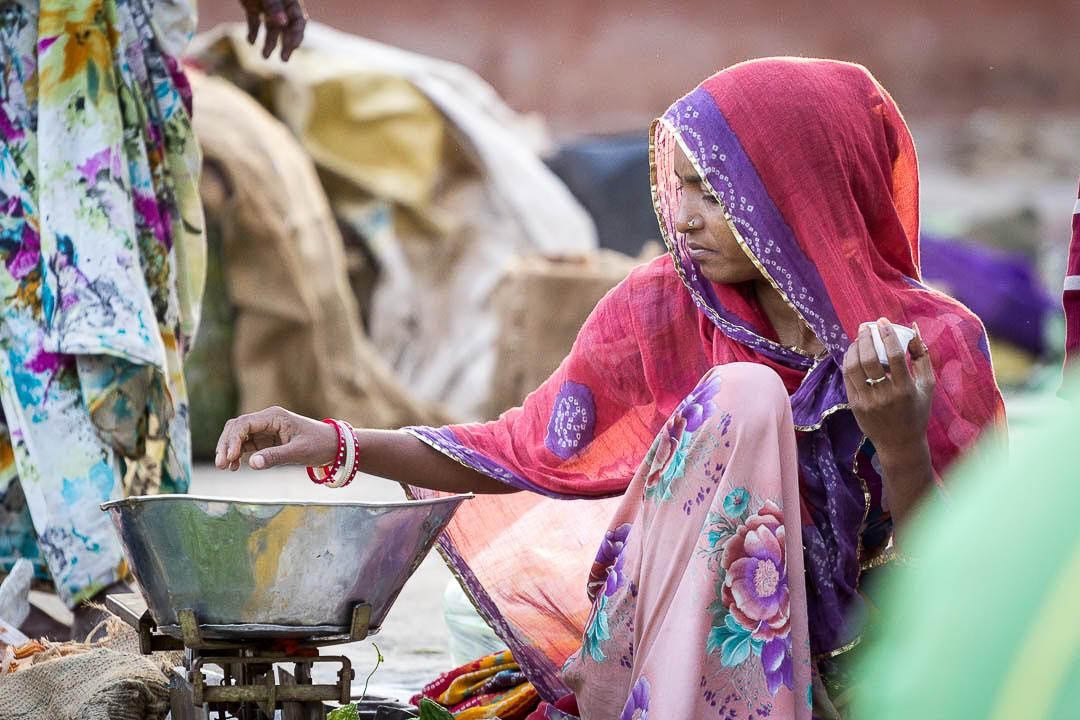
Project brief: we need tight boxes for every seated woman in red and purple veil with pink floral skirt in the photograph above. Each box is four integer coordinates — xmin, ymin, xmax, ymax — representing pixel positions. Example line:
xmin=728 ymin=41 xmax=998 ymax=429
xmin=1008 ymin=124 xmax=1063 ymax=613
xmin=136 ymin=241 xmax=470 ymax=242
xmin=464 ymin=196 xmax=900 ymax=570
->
xmin=217 ymin=58 xmax=1003 ymax=720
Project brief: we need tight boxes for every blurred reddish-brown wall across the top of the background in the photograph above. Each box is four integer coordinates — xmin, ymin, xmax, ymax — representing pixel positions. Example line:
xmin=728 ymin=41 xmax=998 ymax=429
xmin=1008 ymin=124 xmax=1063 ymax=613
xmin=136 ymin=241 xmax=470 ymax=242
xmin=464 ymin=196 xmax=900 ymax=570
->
xmin=200 ymin=0 xmax=1080 ymax=133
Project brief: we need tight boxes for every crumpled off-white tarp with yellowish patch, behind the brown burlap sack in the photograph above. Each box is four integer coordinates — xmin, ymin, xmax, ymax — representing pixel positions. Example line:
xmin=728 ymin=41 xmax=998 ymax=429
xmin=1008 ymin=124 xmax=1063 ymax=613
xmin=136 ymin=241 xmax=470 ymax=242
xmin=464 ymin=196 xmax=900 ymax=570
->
xmin=192 ymin=25 xmax=596 ymax=418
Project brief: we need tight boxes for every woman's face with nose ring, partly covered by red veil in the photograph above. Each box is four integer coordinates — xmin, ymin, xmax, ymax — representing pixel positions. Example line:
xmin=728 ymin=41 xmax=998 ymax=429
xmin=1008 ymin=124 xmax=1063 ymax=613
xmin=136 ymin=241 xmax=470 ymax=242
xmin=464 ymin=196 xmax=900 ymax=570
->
xmin=675 ymin=147 xmax=762 ymax=285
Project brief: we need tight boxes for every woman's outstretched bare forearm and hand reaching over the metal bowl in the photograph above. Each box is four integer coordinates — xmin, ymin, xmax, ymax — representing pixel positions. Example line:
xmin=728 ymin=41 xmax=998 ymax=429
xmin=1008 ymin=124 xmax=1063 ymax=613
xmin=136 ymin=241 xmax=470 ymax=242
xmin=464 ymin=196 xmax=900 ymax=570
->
xmin=215 ymin=407 xmax=516 ymax=493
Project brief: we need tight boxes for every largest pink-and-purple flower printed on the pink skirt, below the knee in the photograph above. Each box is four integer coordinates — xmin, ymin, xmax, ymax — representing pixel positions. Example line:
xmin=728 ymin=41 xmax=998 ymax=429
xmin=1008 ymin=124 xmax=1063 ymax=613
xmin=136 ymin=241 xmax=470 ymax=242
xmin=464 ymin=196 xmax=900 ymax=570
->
xmin=720 ymin=500 xmax=791 ymax=640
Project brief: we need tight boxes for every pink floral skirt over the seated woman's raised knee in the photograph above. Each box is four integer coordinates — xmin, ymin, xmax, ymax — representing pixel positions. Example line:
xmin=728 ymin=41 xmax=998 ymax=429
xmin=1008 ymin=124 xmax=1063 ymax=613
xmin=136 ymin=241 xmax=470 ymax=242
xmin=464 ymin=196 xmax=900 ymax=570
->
xmin=557 ymin=364 xmax=810 ymax=720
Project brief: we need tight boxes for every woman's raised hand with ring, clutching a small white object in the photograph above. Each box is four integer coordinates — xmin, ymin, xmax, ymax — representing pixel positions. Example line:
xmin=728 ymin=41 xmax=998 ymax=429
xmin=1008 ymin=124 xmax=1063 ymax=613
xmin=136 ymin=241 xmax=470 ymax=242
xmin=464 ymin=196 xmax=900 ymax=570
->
xmin=843 ymin=318 xmax=935 ymax=456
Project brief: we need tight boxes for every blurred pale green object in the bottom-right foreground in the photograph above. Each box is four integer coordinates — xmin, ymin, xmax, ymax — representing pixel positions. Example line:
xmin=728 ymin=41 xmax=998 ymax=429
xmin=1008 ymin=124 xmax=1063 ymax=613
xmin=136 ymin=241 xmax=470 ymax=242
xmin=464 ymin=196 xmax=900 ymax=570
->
xmin=853 ymin=376 xmax=1080 ymax=720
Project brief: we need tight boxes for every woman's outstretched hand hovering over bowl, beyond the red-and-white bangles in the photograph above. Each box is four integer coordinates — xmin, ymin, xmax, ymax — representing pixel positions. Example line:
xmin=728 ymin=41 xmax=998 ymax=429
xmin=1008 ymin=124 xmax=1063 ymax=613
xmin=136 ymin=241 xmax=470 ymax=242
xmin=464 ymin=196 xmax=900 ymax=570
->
xmin=214 ymin=407 xmax=338 ymax=471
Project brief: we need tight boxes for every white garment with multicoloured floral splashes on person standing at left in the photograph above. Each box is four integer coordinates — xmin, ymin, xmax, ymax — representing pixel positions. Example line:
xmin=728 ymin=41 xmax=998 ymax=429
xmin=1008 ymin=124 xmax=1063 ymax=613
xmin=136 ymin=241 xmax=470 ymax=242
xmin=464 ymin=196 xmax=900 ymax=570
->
xmin=0 ymin=0 xmax=205 ymax=604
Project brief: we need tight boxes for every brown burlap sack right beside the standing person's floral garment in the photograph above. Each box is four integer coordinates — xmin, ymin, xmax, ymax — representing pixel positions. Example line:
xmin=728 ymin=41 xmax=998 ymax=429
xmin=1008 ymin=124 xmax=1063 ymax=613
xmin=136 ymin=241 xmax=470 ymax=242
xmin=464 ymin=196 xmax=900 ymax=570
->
xmin=185 ymin=72 xmax=443 ymax=455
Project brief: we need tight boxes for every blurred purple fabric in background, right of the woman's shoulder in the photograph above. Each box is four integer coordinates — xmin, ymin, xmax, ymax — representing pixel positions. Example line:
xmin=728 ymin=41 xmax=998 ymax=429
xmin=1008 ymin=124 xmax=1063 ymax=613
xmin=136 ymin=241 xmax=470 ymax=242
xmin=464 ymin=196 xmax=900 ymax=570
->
xmin=920 ymin=233 xmax=1057 ymax=356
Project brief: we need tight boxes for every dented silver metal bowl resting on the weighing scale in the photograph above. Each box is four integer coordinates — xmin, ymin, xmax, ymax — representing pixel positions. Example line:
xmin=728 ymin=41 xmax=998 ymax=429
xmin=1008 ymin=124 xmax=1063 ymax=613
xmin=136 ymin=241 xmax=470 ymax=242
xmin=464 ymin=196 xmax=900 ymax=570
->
xmin=102 ymin=495 xmax=471 ymax=637
